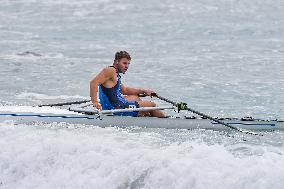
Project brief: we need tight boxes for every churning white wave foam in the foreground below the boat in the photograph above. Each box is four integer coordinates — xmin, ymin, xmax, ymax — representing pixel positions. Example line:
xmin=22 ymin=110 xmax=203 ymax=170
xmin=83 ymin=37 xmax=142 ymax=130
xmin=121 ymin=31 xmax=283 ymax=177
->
xmin=0 ymin=124 xmax=284 ymax=189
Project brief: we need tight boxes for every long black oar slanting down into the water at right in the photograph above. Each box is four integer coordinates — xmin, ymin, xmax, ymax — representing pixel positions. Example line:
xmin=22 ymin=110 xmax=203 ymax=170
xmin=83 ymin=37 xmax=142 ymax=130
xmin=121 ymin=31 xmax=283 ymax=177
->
xmin=152 ymin=93 xmax=263 ymax=136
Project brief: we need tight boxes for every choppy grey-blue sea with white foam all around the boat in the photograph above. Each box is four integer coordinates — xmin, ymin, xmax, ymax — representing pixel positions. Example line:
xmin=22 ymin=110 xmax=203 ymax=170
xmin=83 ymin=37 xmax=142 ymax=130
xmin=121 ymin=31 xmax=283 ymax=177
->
xmin=0 ymin=0 xmax=284 ymax=189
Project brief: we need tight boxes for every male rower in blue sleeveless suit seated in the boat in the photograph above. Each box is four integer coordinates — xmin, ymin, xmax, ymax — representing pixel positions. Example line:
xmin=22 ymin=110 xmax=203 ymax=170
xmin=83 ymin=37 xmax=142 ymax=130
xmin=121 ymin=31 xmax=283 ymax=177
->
xmin=90 ymin=51 xmax=165 ymax=117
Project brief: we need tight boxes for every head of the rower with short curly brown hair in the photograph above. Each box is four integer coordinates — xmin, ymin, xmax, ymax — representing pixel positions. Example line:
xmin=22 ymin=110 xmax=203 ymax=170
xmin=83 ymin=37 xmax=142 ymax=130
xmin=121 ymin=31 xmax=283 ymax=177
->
xmin=113 ymin=51 xmax=131 ymax=74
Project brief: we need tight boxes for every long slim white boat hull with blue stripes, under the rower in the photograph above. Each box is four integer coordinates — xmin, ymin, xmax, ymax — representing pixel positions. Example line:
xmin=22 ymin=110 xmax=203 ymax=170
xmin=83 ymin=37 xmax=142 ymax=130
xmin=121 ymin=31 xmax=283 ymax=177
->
xmin=0 ymin=112 xmax=284 ymax=131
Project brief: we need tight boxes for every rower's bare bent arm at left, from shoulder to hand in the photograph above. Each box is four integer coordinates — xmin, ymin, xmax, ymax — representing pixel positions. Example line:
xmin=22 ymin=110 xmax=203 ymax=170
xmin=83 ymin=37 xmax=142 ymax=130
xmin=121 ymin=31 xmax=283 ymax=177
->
xmin=90 ymin=68 xmax=115 ymax=110
